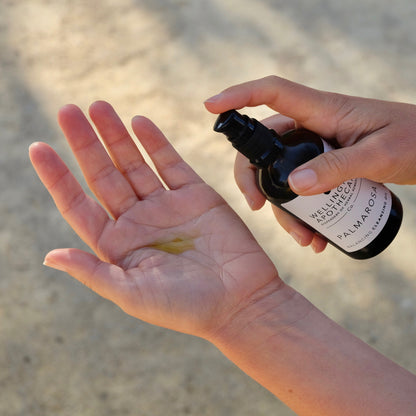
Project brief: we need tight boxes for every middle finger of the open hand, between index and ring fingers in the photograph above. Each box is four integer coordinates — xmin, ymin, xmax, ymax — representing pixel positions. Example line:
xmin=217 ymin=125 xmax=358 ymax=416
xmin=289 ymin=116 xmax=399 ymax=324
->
xmin=58 ymin=105 xmax=137 ymax=218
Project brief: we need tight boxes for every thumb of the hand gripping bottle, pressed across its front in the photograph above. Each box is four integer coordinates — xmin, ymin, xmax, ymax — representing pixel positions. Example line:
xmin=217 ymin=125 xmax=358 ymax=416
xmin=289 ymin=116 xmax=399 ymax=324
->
xmin=289 ymin=144 xmax=380 ymax=195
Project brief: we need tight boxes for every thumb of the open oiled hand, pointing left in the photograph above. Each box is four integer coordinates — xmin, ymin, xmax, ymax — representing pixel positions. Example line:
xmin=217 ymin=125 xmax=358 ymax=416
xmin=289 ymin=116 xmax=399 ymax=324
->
xmin=43 ymin=249 xmax=127 ymax=304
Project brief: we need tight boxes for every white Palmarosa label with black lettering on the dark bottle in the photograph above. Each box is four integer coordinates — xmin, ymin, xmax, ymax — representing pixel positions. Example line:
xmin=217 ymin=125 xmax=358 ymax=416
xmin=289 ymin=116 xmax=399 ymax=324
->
xmin=281 ymin=142 xmax=392 ymax=253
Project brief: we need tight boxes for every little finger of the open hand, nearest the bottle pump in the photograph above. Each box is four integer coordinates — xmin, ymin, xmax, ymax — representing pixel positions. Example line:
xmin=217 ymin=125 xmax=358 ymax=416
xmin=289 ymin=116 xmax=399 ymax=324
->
xmin=132 ymin=116 xmax=202 ymax=189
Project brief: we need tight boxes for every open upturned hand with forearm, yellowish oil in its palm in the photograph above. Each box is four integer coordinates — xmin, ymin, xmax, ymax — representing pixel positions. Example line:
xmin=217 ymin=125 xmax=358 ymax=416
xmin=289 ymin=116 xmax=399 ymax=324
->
xmin=30 ymin=96 xmax=416 ymax=416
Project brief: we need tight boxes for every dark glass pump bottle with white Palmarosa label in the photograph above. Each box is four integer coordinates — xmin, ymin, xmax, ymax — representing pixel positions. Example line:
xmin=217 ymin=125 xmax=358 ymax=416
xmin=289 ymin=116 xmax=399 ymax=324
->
xmin=214 ymin=110 xmax=403 ymax=259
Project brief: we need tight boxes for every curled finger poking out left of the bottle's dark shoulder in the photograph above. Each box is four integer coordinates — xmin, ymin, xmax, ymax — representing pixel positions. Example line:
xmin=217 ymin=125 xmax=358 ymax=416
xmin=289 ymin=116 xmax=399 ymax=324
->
xmin=234 ymin=152 xmax=266 ymax=211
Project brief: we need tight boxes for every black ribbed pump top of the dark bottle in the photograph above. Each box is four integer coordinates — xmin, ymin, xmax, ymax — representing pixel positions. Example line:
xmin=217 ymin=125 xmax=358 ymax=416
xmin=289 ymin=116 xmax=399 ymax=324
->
xmin=214 ymin=110 xmax=283 ymax=168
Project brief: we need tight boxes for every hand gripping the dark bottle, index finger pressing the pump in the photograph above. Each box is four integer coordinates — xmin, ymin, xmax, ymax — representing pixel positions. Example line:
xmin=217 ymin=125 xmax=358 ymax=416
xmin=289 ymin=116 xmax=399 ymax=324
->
xmin=205 ymin=76 xmax=416 ymax=252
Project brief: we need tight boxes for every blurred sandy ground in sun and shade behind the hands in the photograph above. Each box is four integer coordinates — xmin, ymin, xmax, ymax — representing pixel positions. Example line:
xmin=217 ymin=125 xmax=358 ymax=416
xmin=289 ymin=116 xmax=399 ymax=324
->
xmin=0 ymin=0 xmax=416 ymax=416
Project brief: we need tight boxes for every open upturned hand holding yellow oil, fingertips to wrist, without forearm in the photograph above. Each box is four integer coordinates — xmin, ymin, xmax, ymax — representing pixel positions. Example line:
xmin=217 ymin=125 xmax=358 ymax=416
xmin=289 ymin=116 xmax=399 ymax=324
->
xmin=30 ymin=102 xmax=280 ymax=336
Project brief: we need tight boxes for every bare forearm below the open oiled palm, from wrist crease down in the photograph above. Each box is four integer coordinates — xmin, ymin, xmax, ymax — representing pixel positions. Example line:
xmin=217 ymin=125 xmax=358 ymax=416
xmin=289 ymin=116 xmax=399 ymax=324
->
xmin=209 ymin=279 xmax=416 ymax=416
